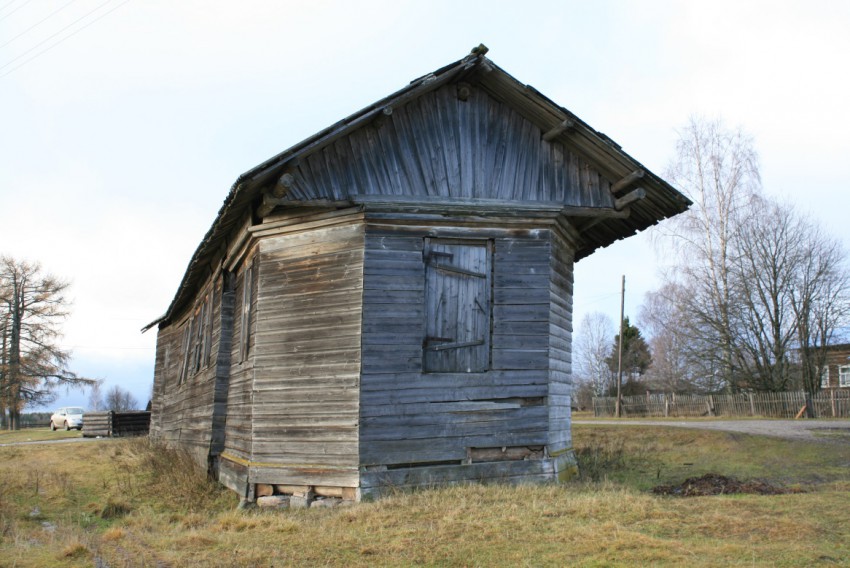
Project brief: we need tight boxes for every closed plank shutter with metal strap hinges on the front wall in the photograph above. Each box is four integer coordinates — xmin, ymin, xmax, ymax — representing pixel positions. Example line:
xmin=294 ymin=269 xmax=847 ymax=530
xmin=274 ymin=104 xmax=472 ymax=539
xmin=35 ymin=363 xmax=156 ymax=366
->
xmin=422 ymin=239 xmax=493 ymax=373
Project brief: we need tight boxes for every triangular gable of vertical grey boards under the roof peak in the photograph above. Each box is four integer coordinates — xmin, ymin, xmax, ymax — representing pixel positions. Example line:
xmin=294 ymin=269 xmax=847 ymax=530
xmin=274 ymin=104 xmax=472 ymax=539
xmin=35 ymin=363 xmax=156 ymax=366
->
xmin=287 ymin=85 xmax=613 ymax=207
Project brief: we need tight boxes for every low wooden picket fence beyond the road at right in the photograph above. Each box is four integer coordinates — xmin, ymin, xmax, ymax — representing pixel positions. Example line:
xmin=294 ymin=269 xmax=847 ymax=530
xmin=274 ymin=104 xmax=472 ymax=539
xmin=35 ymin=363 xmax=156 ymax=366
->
xmin=593 ymin=389 xmax=850 ymax=418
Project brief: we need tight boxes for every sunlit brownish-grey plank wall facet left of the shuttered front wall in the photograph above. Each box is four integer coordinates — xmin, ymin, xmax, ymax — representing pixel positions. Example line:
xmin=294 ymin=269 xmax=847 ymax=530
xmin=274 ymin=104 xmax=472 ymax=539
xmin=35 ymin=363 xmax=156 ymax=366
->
xmin=247 ymin=214 xmax=364 ymax=487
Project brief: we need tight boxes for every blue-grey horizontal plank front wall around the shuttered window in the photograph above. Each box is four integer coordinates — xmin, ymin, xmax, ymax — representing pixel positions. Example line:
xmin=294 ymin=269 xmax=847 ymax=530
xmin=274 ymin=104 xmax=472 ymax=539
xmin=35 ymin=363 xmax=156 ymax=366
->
xmin=360 ymin=223 xmax=551 ymax=494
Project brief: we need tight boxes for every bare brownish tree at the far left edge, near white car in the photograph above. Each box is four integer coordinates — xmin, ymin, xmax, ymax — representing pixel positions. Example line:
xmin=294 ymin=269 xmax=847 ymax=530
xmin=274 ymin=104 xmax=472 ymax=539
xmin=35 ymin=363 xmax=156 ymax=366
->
xmin=0 ymin=256 xmax=91 ymax=429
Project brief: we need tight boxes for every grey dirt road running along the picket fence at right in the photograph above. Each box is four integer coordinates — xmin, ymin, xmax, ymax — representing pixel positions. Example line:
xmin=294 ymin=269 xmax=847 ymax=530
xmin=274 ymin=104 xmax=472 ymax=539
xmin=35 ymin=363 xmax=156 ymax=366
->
xmin=572 ymin=419 xmax=850 ymax=444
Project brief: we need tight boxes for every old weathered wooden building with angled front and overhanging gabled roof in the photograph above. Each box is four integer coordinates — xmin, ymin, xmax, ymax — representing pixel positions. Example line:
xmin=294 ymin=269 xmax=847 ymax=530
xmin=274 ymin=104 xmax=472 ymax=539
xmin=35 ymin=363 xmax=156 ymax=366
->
xmin=146 ymin=46 xmax=689 ymax=499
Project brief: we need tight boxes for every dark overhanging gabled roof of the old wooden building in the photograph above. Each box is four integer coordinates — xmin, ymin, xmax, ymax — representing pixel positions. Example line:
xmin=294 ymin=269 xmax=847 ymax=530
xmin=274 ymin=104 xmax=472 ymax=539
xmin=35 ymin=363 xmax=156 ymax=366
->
xmin=145 ymin=45 xmax=690 ymax=330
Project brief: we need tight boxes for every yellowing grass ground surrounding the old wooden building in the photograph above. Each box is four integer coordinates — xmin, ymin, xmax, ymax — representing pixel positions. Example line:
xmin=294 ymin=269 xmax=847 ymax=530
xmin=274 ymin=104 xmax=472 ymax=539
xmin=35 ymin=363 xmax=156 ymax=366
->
xmin=0 ymin=425 xmax=850 ymax=567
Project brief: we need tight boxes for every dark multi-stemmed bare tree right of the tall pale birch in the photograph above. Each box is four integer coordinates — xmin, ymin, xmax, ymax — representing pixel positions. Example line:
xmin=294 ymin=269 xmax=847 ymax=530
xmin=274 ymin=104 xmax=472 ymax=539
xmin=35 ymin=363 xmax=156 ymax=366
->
xmin=735 ymin=199 xmax=850 ymax=393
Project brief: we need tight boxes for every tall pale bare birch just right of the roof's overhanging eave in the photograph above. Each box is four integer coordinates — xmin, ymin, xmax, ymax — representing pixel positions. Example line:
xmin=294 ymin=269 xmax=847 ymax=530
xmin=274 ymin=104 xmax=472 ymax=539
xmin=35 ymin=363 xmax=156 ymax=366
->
xmin=655 ymin=117 xmax=761 ymax=388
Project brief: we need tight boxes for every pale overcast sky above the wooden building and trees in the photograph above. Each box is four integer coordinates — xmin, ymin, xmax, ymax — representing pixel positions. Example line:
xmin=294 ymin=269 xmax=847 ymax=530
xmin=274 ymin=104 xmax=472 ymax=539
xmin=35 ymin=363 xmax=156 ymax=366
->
xmin=0 ymin=0 xmax=850 ymax=406
